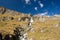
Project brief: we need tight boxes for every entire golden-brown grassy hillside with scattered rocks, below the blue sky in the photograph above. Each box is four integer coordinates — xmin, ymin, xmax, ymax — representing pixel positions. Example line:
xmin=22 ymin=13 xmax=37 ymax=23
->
xmin=0 ymin=7 xmax=60 ymax=40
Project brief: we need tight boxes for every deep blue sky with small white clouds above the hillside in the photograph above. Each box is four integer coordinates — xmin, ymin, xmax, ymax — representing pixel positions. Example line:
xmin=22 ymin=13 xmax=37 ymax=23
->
xmin=0 ymin=0 xmax=60 ymax=15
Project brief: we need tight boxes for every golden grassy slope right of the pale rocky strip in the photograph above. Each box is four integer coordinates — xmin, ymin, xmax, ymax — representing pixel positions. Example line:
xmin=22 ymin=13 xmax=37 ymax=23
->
xmin=29 ymin=17 xmax=60 ymax=40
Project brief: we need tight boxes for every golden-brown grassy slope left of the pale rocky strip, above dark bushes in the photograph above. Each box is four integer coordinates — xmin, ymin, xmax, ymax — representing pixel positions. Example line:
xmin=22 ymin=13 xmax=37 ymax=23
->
xmin=0 ymin=10 xmax=29 ymax=34
